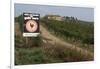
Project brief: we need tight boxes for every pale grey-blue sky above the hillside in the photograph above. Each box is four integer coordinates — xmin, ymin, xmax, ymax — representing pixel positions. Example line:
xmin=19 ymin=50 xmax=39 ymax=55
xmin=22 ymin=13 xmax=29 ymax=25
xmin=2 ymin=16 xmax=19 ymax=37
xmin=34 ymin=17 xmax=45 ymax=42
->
xmin=14 ymin=3 xmax=94 ymax=21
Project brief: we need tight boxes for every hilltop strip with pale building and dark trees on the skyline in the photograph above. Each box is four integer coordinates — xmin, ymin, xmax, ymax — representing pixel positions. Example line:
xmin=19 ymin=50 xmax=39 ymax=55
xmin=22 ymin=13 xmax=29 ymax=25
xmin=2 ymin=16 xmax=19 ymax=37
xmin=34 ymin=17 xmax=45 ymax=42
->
xmin=43 ymin=15 xmax=94 ymax=23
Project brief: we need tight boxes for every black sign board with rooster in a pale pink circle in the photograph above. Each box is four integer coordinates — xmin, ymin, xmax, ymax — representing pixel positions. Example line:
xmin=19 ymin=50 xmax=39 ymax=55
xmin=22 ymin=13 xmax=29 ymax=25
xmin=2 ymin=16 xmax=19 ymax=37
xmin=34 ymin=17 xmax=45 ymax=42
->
xmin=23 ymin=13 xmax=40 ymax=37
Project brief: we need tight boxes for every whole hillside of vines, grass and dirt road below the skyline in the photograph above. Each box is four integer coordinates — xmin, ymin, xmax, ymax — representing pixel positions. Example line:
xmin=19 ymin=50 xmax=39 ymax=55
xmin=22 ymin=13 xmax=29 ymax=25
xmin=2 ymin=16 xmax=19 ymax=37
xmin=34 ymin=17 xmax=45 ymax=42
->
xmin=15 ymin=16 xmax=94 ymax=65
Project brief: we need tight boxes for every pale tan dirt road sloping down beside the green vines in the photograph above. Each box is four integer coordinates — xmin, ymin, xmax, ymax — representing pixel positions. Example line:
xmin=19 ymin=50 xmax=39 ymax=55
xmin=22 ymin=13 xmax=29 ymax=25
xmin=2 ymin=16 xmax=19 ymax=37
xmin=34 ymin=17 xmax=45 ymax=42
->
xmin=40 ymin=25 xmax=93 ymax=56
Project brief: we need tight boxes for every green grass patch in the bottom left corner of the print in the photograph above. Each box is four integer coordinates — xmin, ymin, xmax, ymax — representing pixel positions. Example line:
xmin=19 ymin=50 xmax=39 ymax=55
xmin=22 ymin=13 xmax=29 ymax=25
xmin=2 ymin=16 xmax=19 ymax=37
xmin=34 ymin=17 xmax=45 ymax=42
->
xmin=15 ymin=48 xmax=44 ymax=65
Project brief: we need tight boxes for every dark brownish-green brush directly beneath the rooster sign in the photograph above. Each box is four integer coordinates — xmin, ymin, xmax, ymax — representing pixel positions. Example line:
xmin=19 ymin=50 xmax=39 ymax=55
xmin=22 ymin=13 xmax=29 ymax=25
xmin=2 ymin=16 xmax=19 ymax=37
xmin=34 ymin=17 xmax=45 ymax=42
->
xmin=15 ymin=35 xmax=43 ymax=48
